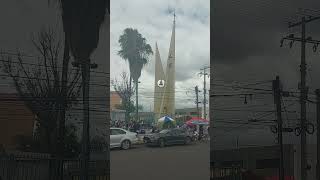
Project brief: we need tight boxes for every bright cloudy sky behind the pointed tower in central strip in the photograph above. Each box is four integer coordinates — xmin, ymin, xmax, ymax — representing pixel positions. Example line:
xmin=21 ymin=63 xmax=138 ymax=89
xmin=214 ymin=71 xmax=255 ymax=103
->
xmin=110 ymin=0 xmax=210 ymax=111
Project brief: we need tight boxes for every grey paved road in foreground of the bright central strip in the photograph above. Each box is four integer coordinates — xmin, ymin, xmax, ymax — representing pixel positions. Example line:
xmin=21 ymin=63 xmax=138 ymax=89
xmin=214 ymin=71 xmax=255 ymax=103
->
xmin=110 ymin=143 xmax=210 ymax=180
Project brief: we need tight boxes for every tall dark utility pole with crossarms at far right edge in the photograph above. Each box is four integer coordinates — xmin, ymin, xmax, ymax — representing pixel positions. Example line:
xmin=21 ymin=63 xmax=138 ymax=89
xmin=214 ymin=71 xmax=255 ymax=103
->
xmin=280 ymin=15 xmax=320 ymax=180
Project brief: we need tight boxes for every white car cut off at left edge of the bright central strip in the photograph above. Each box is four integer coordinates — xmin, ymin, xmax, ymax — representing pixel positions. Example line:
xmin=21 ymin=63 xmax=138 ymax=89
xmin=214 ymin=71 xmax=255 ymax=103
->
xmin=110 ymin=128 xmax=138 ymax=150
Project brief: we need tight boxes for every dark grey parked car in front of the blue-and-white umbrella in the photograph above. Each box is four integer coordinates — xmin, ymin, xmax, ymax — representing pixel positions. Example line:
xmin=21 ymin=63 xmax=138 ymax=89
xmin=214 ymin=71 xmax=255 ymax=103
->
xmin=143 ymin=128 xmax=191 ymax=147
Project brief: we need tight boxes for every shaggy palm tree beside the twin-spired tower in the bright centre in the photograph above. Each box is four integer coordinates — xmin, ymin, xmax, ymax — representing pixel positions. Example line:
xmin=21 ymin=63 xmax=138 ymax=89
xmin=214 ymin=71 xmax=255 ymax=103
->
xmin=118 ymin=28 xmax=153 ymax=120
